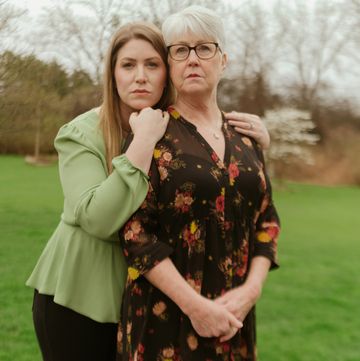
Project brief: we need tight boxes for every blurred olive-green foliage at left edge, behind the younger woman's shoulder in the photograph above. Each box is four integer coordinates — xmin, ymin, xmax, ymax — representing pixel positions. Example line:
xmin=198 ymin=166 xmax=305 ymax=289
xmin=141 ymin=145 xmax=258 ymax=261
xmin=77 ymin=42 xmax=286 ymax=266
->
xmin=0 ymin=51 xmax=99 ymax=154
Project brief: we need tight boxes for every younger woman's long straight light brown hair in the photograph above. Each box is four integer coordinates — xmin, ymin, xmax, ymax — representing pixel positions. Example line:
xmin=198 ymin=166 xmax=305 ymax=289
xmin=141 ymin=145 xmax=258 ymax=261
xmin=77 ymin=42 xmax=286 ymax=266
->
xmin=100 ymin=22 xmax=174 ymax=173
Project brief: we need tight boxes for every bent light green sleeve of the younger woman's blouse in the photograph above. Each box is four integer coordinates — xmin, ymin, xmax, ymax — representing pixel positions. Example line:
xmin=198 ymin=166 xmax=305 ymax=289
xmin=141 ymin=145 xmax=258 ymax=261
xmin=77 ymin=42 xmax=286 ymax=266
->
xmin=55 ymin=122 xmax=148 ymax=240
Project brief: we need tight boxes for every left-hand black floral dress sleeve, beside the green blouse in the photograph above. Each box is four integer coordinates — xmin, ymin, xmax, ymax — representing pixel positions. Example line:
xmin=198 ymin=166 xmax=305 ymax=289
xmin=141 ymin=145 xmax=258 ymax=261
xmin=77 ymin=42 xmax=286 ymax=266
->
xmin=119 ymin=160 xmax=173 ymax=281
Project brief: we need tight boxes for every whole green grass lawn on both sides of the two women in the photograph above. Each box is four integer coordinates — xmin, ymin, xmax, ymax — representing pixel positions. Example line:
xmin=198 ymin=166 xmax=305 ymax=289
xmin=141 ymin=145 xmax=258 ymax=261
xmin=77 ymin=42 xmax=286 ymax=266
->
xmin=0 ymin=156 xmax=360 ymax=361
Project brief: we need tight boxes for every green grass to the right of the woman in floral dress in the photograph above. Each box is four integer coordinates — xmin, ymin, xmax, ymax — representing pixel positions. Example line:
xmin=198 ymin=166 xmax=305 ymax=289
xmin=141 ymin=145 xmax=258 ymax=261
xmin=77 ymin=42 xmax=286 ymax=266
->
xmin=258 ymin=185 xmax=360 ymax=361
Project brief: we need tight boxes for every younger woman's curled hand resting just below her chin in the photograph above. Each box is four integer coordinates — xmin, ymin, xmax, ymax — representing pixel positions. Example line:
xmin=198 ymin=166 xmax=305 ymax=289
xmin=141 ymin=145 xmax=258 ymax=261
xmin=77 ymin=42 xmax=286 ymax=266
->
xmin=129 ymin=108 xmax=169 ymax=145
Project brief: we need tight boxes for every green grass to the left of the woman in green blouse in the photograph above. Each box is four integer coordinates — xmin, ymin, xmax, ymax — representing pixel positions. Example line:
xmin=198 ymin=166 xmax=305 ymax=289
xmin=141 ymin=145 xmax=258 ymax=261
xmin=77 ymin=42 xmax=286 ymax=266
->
xmin=0 ymin=156 xmax=65 ymax=361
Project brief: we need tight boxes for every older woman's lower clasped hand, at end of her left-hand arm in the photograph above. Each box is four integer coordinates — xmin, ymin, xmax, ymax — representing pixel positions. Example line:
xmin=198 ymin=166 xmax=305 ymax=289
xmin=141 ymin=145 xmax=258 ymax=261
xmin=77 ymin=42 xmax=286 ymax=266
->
xmin=187 ymin=296 xmax=242 ymax=342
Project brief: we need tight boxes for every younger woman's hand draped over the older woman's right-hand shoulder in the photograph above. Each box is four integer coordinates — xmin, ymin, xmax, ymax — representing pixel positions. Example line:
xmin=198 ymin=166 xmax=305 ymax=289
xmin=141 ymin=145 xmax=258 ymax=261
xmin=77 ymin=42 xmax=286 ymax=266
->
xmin=225 ymin=111 xmax=270 ymax=149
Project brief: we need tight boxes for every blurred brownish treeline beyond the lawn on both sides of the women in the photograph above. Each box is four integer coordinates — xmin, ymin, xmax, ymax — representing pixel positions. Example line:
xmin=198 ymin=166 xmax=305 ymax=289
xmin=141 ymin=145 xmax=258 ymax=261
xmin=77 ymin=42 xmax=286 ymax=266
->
xmin=0 ymin=51 xmax=360 ymax=184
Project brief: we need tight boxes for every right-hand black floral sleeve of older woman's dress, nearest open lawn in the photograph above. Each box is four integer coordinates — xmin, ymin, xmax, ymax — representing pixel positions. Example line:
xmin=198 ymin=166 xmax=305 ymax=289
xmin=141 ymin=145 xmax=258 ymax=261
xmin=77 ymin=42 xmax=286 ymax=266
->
xmin=254 ymin=143 xmax=280 ymax=269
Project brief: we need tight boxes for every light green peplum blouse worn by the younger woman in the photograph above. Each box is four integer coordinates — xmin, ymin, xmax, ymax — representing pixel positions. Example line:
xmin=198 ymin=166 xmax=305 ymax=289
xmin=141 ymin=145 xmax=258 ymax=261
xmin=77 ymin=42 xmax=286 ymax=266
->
xmin=26 ymin=110 xmax=148 ymax=322
